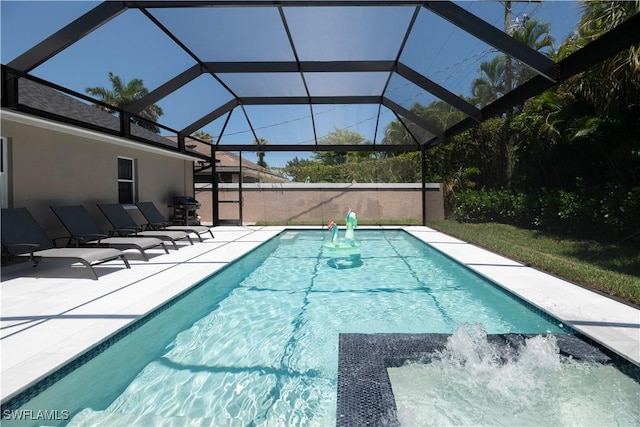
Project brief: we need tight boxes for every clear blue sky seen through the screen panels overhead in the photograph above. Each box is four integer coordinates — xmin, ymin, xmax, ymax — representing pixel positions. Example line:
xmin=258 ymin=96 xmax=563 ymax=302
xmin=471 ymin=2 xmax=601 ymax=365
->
xmin=0 ymin=0 xmax=580 ymax=166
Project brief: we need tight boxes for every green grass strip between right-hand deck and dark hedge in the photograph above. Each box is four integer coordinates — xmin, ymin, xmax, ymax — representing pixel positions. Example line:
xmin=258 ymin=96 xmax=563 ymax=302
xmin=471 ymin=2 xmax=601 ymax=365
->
xmin=427 ymin=220 xmax=640 ymax=305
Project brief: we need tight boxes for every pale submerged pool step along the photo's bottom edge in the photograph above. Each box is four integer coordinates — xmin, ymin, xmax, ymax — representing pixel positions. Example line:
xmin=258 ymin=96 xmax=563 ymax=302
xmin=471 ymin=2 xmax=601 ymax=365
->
xmin=67 ymin=409 xmax=246 ymax=427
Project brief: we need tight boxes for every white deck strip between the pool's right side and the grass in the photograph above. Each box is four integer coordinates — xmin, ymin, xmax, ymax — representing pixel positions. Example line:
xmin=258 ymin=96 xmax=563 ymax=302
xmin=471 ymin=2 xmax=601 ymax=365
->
xmin=404 ymin=227 xmax=640 ymax=366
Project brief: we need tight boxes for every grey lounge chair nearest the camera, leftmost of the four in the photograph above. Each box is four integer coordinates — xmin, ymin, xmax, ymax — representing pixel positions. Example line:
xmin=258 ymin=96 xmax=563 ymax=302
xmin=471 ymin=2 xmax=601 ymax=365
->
xmin=2 ymin=208 xmax=131 ymax=280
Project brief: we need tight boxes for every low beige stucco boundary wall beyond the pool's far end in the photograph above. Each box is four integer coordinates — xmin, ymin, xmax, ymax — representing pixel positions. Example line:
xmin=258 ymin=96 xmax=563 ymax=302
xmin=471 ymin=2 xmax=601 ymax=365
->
xmin=195 ymin=183 xmax=444 ymax=224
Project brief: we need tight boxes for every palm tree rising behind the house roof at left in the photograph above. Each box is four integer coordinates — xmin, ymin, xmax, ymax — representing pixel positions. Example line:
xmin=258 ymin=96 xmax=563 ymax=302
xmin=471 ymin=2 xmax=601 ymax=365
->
xmin=85 ymin=72 xmax=163 ymax=133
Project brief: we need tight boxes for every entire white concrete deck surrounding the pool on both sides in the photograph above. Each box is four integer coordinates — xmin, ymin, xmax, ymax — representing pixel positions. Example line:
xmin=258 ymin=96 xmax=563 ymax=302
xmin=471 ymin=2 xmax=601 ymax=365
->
xmin=0 ymin=226 xmax=640 ymax=402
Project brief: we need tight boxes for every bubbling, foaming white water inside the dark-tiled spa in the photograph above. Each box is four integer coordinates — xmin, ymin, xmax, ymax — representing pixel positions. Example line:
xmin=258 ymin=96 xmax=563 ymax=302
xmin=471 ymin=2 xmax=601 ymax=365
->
xmin=388 ymin=325 xmax=640 ymax=426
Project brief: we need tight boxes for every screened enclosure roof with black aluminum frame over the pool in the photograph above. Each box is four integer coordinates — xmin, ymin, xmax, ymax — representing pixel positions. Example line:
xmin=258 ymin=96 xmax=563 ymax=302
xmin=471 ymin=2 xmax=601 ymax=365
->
xmin=2 ymin=0 xmax=640 ymax=224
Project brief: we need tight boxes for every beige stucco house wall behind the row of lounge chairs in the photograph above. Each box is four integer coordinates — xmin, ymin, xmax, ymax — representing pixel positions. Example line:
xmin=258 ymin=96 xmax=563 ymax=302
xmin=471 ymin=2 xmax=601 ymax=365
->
xmin=1 ymin=120 xmax=193 ymax=237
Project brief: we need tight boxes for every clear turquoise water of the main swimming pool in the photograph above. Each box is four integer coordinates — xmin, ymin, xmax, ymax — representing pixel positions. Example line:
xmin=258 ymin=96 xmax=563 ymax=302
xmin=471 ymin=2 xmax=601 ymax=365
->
xmin=11 ymin=230 xmax=568 ymax=426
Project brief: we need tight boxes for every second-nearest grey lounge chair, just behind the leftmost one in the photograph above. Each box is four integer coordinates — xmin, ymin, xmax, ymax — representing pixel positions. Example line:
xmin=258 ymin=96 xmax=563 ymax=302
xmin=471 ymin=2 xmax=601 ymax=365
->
xmin=51 ymin=205 xmax=169 ymax=261
